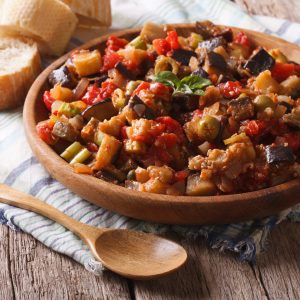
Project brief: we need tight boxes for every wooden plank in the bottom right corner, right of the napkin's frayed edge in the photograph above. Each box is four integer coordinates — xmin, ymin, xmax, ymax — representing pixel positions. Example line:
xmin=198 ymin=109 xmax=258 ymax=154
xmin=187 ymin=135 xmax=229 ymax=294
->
xmin=254 ymin=222 xmax=300 ymax=300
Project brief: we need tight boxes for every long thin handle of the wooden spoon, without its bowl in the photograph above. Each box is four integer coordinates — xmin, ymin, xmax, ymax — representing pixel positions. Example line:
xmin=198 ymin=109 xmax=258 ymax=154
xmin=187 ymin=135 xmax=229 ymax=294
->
xmin=0 ymin=184 xmax=105 ymax=240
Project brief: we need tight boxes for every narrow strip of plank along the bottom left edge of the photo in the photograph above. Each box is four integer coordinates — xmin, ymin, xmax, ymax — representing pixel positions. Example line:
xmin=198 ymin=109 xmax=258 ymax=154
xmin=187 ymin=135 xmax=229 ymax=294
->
xmin=0 ymin=225 xmax=14 ymax=300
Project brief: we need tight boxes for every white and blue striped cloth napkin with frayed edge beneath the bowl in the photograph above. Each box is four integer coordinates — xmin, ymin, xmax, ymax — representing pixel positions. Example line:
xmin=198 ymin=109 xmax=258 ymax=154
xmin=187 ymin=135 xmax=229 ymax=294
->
xmin=0 ymin=0 xmax=300 ymax=274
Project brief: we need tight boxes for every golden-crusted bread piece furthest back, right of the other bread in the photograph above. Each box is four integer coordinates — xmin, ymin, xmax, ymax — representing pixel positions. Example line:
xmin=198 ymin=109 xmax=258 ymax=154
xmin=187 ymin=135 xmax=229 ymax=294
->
xmin=61 ymin=0 xmax=111 ymax=28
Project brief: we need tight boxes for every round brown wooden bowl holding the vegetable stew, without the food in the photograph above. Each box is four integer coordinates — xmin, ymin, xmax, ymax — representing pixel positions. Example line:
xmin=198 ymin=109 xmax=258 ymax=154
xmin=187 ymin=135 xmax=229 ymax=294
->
xmin=23 ymin=24 xmax=300 ymax=224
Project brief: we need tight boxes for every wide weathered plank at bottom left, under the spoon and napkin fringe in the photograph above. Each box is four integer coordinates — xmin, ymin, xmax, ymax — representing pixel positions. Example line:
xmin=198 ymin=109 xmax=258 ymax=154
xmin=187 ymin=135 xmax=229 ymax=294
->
xmin=4 ymin=226 xmax=130 ymax=300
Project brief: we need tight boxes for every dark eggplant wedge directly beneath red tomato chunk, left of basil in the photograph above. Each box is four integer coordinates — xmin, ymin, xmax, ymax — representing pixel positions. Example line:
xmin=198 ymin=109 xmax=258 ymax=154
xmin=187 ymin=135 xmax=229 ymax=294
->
xmin=81 ymin=98 xmax=118 ymax=122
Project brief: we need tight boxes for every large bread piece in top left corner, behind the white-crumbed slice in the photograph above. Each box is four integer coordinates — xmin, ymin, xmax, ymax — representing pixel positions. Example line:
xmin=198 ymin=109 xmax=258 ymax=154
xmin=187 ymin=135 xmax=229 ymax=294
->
xmin=0 ymin=0 xmax=78 ymax=55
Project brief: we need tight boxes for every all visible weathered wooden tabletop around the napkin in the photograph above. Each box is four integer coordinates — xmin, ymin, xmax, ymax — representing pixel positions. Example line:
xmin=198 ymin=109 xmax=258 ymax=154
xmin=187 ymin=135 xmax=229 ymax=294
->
xmin=0 ymin=0 xmax=300 ymax=300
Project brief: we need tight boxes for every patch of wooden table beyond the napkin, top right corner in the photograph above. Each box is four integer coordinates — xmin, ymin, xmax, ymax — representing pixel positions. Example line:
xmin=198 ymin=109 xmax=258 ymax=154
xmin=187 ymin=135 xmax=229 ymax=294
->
xmin=234 ymin=0 xmax=300 ymax=22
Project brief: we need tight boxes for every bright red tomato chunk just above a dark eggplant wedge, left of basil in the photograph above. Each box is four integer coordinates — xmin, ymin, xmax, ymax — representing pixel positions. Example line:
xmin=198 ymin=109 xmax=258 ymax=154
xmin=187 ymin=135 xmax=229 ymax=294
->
xmin=82 ymin=81 xmax=117 ymax=105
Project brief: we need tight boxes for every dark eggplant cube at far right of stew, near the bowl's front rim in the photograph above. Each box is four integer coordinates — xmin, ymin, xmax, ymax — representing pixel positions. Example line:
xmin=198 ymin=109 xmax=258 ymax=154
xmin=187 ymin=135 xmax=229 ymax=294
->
xmin=266 ymin=146 xmax=295 ymax=164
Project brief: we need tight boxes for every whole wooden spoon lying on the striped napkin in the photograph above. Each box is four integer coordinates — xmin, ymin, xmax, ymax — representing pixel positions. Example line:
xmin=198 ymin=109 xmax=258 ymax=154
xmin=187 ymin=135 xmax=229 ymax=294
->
xmin=0 ymin=184 xmax=187 ymax=279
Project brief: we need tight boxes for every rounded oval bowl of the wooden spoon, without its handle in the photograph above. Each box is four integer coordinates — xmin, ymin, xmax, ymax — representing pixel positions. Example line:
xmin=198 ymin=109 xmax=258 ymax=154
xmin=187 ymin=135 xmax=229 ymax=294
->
xmin=90 ymin=229 xmax=187 ymax=279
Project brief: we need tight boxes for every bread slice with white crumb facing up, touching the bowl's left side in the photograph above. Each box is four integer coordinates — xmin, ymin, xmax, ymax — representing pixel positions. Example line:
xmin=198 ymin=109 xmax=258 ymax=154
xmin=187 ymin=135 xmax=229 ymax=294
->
xmin=0 ymin=37 xmax=41 ymax=110
